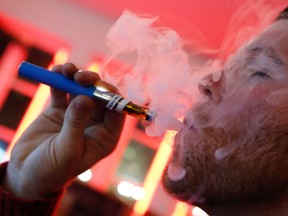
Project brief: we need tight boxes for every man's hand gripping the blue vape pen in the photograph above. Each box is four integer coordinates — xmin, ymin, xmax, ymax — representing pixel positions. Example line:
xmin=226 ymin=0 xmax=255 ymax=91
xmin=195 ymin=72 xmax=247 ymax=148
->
xmin=4 ymin=63 xmax=124 ymax=199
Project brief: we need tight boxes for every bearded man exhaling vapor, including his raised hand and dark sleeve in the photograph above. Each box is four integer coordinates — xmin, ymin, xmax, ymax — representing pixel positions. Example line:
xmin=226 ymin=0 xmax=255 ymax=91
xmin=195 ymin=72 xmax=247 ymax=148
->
xmin=0 ymin=6 xmax=288 ymax=216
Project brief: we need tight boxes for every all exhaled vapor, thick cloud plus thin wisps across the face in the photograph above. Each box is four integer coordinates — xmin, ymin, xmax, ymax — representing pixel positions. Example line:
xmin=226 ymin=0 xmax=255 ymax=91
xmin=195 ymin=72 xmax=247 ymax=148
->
xmin=101 ymin=0 xmax=287 ymax=181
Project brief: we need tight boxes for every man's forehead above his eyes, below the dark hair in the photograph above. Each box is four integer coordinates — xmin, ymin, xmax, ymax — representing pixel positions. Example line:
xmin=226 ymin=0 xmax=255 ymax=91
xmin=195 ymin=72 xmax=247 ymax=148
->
xmin=220 ymin=20 xmax=288 ymax=84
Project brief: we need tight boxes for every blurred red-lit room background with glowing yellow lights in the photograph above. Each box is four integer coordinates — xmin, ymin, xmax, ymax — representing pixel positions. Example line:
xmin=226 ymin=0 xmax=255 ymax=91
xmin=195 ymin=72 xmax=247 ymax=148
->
xmin=0 ymin=0 xmax=287 ymax=216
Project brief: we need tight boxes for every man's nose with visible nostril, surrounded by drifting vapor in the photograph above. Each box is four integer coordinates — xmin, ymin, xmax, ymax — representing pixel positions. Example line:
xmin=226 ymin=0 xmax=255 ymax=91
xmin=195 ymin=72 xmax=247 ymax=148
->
xmin=198 ymin=71 xmax=224 ymax=103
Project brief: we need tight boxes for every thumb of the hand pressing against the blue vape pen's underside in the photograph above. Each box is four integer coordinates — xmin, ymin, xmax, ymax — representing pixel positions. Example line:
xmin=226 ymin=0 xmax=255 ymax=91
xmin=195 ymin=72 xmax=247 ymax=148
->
xmin=60 ymin=96 xmax=94 ymax=145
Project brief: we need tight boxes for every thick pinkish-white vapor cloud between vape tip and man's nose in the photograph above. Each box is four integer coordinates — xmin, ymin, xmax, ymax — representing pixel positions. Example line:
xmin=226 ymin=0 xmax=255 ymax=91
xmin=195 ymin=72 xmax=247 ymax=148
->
xmin=102 ymin=11 xmax=204 ymax=136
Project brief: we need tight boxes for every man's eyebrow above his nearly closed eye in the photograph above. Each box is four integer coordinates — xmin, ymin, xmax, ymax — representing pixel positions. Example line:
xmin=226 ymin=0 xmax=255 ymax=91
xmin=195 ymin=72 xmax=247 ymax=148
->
xmin=247 ymin=46 xmax=285 ymax=67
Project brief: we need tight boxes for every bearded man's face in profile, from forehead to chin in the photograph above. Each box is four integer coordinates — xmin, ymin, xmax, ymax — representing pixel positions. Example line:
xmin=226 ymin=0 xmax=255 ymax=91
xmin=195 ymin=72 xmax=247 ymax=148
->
xmin=163 ymin=20 xmax=288 ymax=205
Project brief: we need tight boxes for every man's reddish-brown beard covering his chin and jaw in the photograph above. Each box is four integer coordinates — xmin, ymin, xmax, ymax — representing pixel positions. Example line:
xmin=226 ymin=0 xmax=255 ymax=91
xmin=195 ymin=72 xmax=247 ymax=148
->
xmin=162 ymin=100 xmax=288 ymax=206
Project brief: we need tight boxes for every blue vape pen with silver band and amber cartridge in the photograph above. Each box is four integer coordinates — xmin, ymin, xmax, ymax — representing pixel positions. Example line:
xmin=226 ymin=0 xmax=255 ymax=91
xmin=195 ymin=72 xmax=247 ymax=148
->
xmin=18 ymin=62 xmax=155 ymax=122
